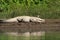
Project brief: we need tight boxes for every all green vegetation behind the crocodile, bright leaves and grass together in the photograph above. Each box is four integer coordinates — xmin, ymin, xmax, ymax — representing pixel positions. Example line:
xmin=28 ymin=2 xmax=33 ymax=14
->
xmin=0 ymin=0 xmax=60 ymax=19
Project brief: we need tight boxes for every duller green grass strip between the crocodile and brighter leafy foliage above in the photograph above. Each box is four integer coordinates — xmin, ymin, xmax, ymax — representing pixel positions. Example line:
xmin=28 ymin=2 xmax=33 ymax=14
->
xmin=0 ymin=6 xmax=60 ymax=19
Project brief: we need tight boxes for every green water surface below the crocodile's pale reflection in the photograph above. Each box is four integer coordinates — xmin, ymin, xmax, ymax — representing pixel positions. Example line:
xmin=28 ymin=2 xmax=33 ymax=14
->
xmin=0 ymin=32 xmax=60 ymax=40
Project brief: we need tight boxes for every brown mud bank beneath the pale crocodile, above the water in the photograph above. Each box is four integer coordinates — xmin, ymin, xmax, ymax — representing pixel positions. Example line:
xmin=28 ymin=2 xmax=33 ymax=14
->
xmin=0 ymin=19 xmax=60 ymax=33
